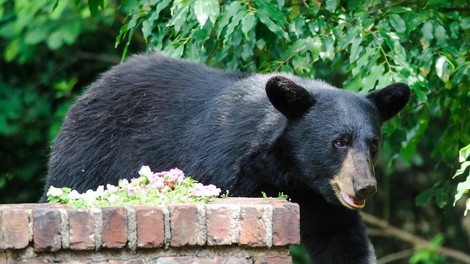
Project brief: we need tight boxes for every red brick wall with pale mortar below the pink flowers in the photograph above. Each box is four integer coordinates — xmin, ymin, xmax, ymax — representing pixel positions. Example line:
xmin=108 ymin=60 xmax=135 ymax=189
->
xmin=0 ymin=198 xmax=300 ymax=264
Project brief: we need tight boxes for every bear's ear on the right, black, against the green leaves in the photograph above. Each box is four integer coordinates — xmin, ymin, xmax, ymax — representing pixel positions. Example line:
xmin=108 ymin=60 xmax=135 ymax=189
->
xmin=366 ymin=83 xmax=410 ymax=123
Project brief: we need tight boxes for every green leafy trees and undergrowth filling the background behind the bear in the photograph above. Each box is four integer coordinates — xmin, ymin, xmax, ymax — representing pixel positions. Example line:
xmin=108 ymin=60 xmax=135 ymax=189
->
xmin=0 ymin=0 xmax=470 ymax=263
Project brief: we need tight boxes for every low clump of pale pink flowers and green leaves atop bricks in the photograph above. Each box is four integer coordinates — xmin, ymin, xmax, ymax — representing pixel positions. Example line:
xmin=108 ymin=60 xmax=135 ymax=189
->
xmin=47 ymin=166 xmax=221 ymax=208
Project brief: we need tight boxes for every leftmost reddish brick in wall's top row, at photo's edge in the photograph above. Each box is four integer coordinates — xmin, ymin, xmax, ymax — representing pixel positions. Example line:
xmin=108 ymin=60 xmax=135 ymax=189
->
xmin=0 ymin=208 xmax=29 ymax=249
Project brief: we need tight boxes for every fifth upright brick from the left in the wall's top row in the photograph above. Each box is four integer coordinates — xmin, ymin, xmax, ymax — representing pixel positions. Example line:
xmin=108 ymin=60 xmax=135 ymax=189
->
xmin=134 ymin=206 xmax=165 ymax=248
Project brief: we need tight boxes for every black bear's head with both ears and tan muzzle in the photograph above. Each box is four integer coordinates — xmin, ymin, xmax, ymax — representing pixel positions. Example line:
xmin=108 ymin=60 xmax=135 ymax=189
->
xmin=266 ymin=76 xmax=410 ymax=209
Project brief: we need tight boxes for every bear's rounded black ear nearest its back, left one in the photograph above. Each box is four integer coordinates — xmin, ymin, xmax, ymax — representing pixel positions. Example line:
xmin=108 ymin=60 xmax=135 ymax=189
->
xmin=266 ymin=76 xmax=315 ymax=119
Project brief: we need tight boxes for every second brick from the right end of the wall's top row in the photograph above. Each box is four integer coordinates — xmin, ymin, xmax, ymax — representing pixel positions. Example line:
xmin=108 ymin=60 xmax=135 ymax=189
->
xmin=240 ymin=206 xmax=267 ymax=247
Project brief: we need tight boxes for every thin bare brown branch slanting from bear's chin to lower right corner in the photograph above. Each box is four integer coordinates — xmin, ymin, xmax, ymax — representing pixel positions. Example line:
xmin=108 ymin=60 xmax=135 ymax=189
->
xmin=361 ymin=212 xmax=470 ymax=263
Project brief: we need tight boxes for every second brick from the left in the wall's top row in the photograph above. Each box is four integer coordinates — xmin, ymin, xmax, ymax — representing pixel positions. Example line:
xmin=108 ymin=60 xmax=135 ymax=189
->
xmin=33 ymin=208 xmax=62 ymax=252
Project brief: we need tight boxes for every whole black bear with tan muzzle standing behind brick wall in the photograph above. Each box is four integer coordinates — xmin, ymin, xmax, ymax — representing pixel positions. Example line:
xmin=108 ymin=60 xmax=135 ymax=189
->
xmin=43 ymin=54 xmax=410 ymax=264
